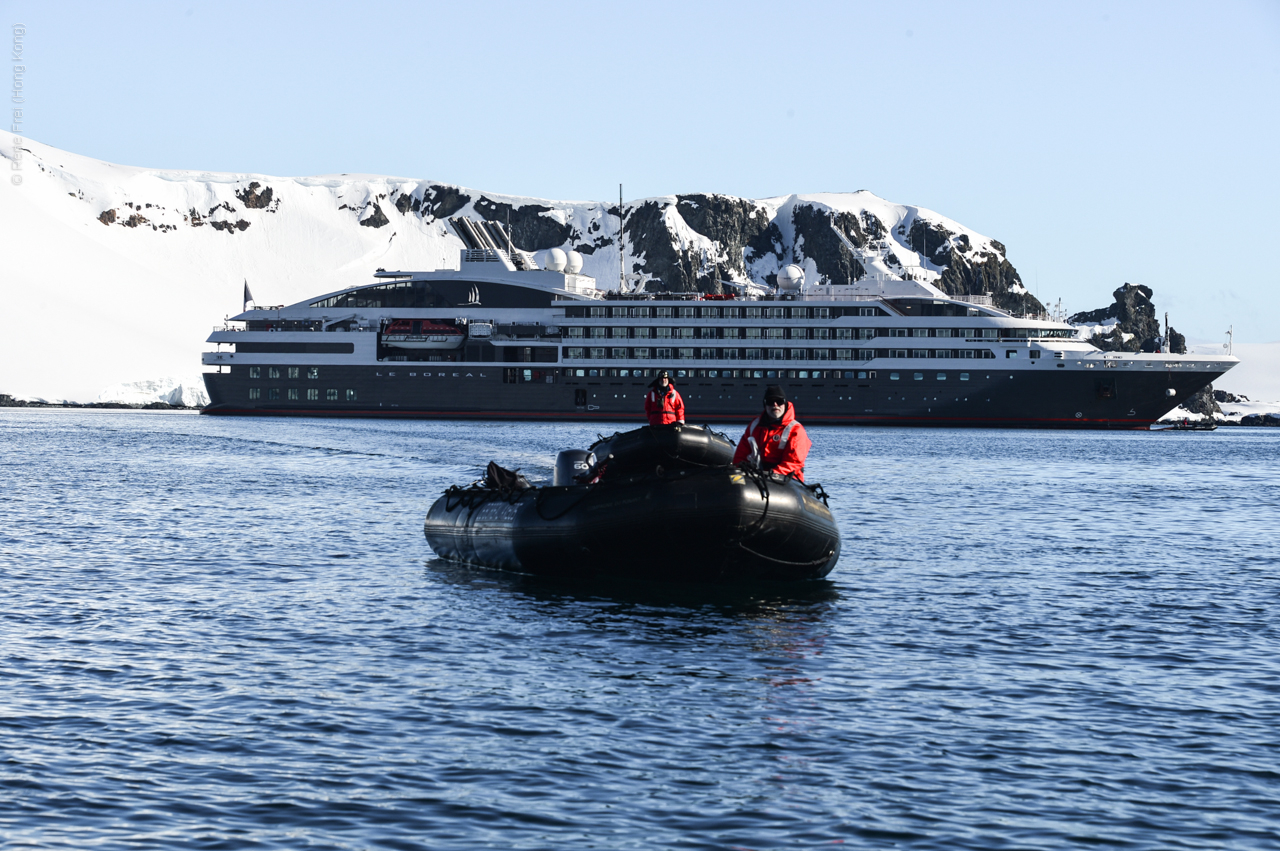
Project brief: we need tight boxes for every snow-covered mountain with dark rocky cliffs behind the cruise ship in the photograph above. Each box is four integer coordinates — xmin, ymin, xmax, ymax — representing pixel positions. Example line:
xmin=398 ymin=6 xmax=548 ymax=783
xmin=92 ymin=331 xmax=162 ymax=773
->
xmin=0 ymin=132 xmax=1024 ymax=401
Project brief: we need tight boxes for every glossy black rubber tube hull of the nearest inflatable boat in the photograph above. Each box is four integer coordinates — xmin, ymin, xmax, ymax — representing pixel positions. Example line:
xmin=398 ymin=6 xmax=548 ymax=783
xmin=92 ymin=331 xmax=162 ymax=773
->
xmin=424 ymin=467 xmax=840 ymax=581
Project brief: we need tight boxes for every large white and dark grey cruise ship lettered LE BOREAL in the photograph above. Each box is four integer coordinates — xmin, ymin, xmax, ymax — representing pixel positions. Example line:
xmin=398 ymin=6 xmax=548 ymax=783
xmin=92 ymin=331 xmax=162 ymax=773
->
xmin=202 ymin=220 xmax=1238 ymax=429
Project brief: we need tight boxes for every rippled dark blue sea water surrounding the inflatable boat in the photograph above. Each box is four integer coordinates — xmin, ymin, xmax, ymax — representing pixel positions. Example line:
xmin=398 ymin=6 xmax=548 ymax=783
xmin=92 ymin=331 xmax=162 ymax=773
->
xmin=0 ymin=411 xmax=1280 ymax=848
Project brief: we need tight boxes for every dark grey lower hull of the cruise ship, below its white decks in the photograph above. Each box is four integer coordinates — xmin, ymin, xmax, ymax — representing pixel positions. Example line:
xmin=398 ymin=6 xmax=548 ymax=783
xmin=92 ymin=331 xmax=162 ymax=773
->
xmin=197 ymin=362 xmax=1221 ymax=429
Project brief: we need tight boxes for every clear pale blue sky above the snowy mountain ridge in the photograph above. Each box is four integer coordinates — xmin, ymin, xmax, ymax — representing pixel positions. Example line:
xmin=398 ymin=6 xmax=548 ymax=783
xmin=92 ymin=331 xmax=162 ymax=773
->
xmin=0 ymin=0 xmax=1280 ymax=342
